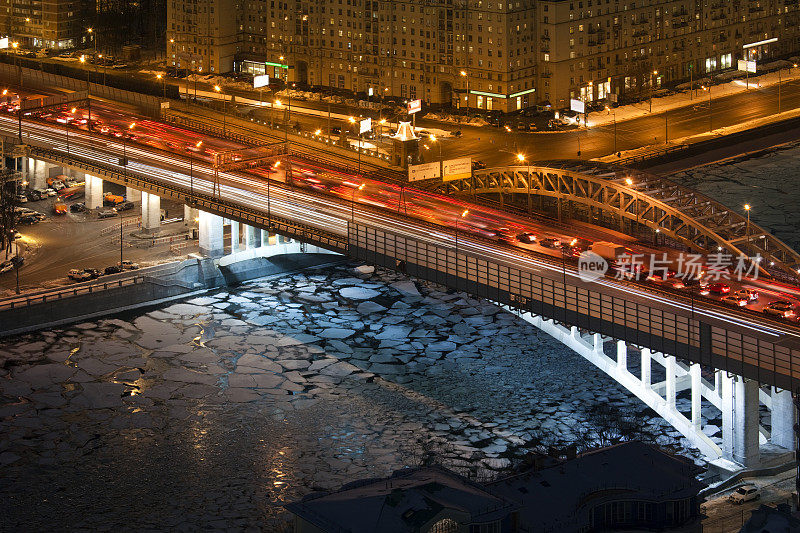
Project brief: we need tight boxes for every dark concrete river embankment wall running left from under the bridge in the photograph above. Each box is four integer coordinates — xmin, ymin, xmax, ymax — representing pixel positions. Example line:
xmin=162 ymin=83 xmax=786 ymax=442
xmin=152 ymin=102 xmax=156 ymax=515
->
xmin=0 ymin=253 xmax=341 ymax=336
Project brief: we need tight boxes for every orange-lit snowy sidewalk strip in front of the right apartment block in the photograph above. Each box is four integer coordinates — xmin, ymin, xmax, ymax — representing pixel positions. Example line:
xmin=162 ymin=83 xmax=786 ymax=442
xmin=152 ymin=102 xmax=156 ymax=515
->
xmin=588 ymin=62 xmax=800 ymax=128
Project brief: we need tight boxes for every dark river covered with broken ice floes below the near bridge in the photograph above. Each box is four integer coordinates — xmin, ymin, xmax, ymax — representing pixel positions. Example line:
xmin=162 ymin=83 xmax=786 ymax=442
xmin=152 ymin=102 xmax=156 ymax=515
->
xmin=0 ymin=266 xmax=719 ymax=531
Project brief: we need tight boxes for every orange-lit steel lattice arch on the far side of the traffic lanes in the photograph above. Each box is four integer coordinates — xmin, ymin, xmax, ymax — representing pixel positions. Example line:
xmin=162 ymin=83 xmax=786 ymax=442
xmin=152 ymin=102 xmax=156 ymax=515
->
xmin=423 ymin=160 xmax=800 ymax=281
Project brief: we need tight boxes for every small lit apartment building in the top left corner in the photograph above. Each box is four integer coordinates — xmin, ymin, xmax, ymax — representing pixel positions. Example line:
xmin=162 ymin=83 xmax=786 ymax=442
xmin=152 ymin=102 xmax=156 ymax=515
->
xmin=0 ymin=0 xmax=86 ymax=49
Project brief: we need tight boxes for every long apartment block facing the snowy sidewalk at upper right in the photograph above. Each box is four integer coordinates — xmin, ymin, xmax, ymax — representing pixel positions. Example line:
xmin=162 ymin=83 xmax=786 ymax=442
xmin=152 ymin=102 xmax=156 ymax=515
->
xmin=535 ymin=0 xmax=800 ymax=107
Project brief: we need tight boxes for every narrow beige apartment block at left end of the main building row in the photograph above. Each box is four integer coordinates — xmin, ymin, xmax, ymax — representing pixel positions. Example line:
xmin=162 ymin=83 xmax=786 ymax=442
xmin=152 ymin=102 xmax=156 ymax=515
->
xmin=166 ymin=0 xmax=234 ymax=73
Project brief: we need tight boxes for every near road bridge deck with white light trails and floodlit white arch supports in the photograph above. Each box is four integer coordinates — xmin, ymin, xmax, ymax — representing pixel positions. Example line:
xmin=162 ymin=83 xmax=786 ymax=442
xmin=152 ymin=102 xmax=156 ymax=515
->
xmin=6 ymin=112 xmax=800 ymax=466
